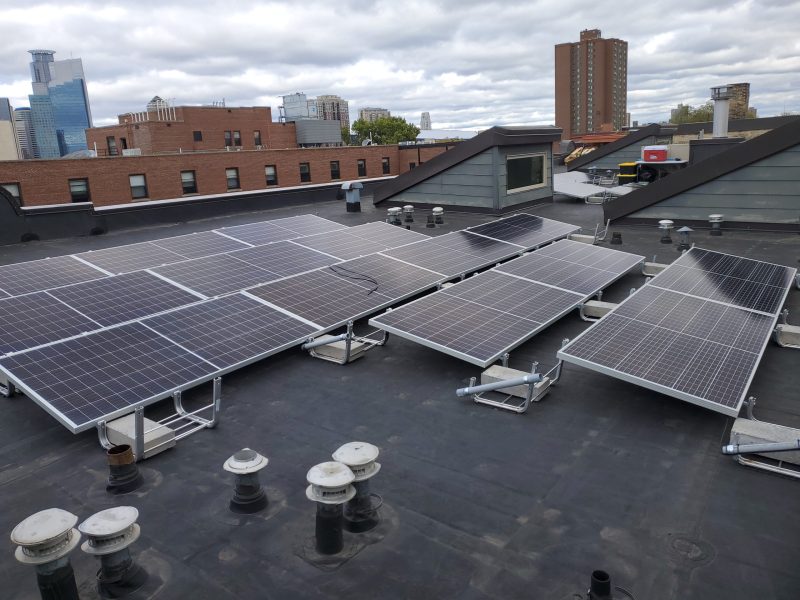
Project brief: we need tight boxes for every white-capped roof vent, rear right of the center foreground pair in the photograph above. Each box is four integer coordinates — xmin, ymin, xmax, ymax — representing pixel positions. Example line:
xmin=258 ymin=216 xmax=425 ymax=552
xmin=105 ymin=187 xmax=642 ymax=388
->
xmin=333 ymin=442 xmax=383 ymax=533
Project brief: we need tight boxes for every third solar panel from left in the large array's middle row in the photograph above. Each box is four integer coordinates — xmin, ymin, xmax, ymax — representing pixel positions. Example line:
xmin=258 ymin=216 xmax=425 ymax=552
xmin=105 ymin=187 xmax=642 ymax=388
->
xmin=152 ymin=254 xmax=279 ymax=298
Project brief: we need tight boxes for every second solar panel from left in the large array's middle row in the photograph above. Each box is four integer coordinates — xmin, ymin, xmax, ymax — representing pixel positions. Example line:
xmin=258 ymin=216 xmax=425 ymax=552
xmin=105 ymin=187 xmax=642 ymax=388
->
xmin=49 ymin=271 xmax=199 ymax=326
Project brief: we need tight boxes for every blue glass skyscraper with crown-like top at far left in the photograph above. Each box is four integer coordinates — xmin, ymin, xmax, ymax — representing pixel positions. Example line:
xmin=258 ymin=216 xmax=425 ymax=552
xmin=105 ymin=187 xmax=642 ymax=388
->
xmin=29 ymin=50 xmax=92 ymax=158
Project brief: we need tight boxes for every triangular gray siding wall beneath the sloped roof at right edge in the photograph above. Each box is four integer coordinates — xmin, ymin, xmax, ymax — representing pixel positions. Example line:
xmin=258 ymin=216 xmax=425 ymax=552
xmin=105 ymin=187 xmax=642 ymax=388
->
xmin=630 ymin=145 xmax=800 ymax=223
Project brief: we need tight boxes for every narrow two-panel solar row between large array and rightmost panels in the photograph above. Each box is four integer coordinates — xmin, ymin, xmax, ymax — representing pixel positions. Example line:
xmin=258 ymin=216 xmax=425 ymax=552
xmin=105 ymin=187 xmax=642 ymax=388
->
xmin=370 ymin=240 xmax=644 ymax=367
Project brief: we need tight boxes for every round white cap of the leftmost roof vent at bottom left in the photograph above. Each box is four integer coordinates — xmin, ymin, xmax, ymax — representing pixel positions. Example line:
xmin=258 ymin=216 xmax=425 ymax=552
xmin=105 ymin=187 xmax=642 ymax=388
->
xmin=11 ymin=508 xmax=81 ymax=565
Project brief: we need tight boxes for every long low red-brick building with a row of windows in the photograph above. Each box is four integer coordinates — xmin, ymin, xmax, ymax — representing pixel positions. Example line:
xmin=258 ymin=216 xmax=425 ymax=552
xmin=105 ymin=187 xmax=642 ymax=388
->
xmin=0 ymin=143 xmax=454 ymax=206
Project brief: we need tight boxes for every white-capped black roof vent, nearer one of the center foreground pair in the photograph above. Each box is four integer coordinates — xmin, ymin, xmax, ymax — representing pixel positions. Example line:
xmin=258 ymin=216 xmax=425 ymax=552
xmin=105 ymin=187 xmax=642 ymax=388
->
xmin=306 ymin=462 xmax=356 ymax=555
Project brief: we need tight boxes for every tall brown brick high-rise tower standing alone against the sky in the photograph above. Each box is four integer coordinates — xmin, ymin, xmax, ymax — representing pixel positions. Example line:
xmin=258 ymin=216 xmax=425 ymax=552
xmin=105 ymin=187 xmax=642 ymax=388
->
xmin=555 ymin=29 xmax=628 ymax=139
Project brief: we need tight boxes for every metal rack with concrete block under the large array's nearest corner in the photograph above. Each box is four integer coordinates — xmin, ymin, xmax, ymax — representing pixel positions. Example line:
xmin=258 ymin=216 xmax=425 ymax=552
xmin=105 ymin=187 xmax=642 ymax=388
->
xmin=97 ymin=377 xmax=222 ymax=462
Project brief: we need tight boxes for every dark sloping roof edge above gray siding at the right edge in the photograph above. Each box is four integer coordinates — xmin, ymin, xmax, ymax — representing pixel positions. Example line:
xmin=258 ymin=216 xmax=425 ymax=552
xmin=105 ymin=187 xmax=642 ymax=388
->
xmin=603 ymin=119 xmax=800 ymax=221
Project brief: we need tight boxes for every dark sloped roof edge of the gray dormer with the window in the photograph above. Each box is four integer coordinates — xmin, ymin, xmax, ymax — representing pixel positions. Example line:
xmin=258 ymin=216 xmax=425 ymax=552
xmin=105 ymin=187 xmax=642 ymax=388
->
xmin=373 ymin=126 xmax=561 ymax=204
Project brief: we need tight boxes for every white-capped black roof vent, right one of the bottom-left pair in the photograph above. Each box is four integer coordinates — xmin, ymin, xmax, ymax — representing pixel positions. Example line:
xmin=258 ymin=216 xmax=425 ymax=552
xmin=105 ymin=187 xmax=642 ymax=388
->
xmin=78 ymin=506 xmax=147 ymax=598
